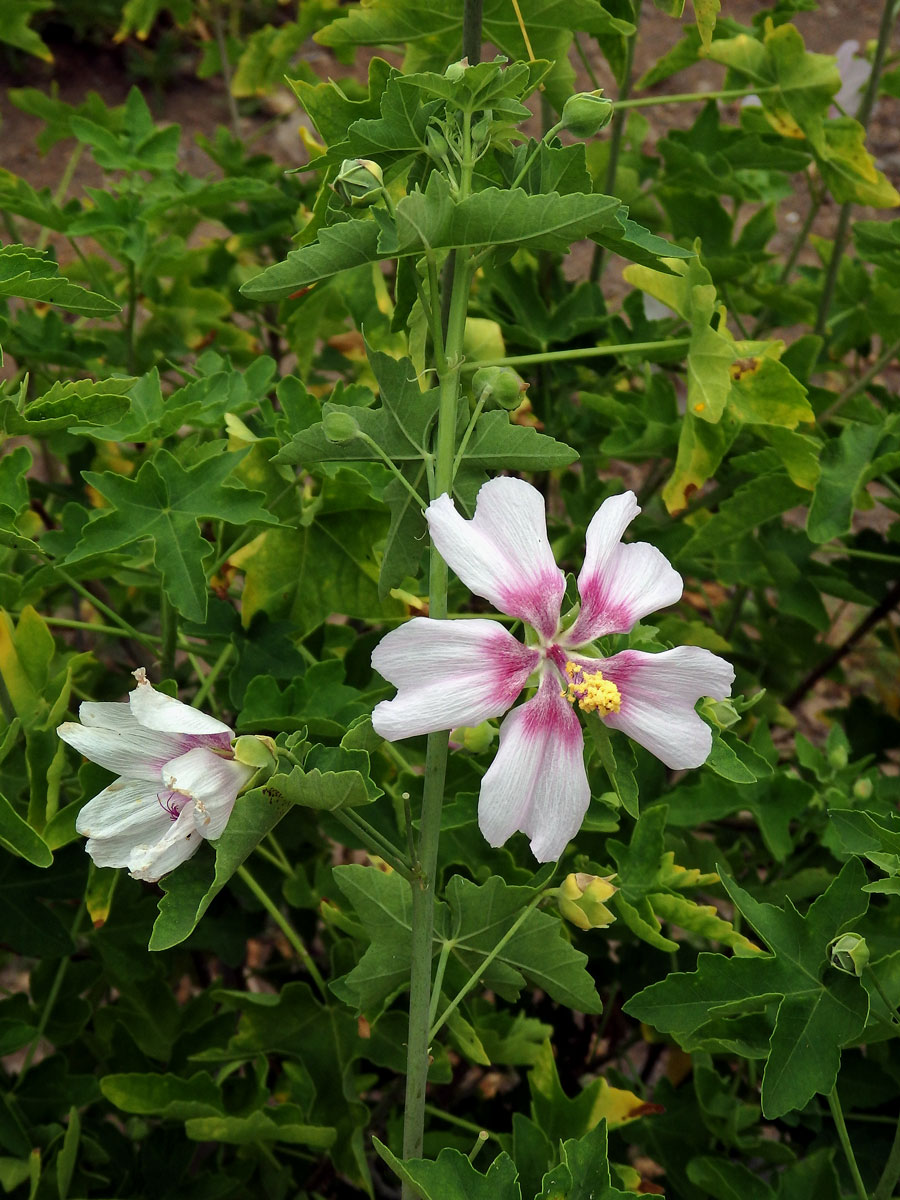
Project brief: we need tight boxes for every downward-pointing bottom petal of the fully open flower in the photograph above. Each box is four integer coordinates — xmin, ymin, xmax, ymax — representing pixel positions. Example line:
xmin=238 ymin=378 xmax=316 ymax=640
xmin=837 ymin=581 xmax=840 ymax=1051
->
xmin=478 ymin=672 xmax=590 ymax=863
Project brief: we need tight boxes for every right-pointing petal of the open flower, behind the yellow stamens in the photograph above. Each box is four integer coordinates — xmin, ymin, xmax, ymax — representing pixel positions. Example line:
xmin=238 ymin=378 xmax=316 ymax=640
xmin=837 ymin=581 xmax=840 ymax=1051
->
xmin=600 ymin=646 xmax=734 ymax=770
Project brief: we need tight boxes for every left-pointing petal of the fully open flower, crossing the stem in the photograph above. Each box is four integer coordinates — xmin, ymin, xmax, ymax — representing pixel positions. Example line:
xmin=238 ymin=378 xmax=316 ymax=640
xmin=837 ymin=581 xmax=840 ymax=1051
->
xmin=372 ymin=617 xmax=540 ymax=742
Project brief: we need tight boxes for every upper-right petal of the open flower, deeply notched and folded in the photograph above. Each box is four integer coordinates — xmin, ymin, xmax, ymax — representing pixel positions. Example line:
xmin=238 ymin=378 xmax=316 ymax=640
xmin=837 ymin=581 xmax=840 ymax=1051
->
xmin=562 ymin=492 xmax=683 ymax=646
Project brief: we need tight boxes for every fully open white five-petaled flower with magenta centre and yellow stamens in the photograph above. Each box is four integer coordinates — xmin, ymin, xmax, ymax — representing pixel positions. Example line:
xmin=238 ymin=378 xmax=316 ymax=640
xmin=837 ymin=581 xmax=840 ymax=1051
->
xmin=372 ymin=478 xmax=734 ymax=862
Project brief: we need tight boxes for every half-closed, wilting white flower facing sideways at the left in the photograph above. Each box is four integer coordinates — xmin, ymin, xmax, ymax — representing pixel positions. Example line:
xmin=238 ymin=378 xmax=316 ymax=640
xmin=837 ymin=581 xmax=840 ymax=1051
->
xmin=58 ymin=667 xmax=254 ymax=881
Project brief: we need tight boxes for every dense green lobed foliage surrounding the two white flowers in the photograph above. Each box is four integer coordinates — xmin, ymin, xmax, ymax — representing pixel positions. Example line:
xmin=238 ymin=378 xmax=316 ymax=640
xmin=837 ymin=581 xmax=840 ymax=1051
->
xmin=0 ymin=0 xmax=900 ymax=1200
